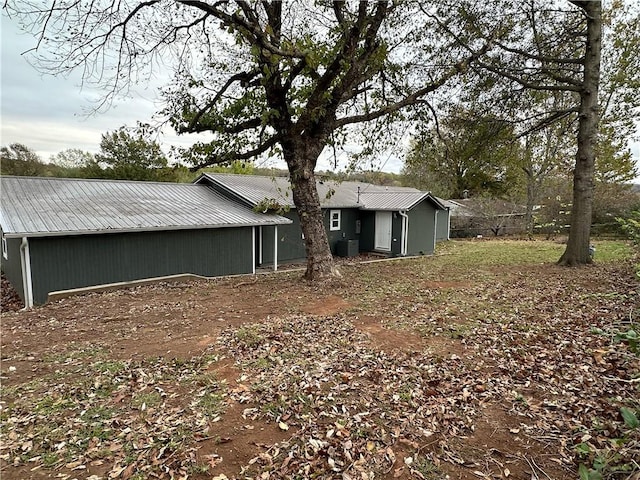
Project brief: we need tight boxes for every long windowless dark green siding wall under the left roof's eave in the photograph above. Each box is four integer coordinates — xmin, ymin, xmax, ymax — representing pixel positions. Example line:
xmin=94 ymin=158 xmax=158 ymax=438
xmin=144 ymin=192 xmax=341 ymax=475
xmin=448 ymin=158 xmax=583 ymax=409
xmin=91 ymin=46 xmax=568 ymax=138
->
xmin=29 ymin=227 xmax=253 ymax=304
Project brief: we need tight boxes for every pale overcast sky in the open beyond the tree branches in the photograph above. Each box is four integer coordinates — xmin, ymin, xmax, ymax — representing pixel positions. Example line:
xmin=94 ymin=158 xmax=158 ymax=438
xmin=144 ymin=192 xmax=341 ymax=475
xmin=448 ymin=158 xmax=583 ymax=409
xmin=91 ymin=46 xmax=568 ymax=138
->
xmin=0 ymin=16 xmax=640 ymax=178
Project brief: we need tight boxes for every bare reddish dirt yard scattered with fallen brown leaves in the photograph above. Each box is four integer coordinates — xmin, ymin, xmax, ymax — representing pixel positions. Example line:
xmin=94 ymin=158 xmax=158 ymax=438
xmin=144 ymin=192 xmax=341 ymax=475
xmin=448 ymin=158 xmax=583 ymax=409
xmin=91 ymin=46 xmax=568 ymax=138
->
xmin=0 ymin=242 xmax=640 ymax=480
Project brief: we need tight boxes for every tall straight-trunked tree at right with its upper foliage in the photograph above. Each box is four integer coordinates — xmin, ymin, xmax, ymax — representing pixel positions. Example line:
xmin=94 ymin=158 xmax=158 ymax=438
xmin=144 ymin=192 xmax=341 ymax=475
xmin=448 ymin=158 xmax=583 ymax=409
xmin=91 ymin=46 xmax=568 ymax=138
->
xmin=458 ymin=0 xmax=639 ymax=265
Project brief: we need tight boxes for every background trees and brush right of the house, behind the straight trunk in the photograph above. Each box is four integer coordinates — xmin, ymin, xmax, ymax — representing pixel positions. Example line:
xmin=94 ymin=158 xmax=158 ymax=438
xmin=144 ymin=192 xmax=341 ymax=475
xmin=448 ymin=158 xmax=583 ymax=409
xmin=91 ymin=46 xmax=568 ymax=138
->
xmin=401 ymin=109 xmax=640 ymax=238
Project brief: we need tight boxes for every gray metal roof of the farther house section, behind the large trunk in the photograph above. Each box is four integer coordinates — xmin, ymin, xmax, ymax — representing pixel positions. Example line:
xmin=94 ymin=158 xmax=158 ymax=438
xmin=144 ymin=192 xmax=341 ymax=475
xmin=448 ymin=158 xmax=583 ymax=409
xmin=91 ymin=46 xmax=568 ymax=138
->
xmin=196 ymin=173 xmax=444 ymax=210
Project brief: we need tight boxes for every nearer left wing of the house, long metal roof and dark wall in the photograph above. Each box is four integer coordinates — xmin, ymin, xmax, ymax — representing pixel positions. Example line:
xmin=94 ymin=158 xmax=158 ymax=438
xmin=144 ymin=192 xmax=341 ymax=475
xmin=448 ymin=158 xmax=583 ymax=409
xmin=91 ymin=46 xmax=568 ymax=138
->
xmin=0 ymin=176 xmax=291 ymax=307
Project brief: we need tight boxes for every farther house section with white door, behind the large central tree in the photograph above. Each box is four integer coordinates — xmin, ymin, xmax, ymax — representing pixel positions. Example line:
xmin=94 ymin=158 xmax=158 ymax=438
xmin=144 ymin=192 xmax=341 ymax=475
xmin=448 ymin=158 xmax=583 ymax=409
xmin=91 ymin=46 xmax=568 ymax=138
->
xmin=195 ymin=173 xmax=448 ymax=264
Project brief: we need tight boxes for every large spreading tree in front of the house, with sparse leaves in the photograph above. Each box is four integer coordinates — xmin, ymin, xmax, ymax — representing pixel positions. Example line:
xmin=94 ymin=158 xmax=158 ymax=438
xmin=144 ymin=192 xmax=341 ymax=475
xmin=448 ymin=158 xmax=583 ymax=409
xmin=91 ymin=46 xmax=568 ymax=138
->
xmin=4 ymin=0 xmax=490 ymax=280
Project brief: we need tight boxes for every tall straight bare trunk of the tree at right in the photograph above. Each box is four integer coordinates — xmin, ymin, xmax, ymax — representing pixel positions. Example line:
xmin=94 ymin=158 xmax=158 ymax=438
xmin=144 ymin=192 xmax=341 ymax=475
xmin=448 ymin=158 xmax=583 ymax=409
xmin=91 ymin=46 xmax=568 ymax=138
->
xmin=558 ymin=0 xmax=602 ymax=266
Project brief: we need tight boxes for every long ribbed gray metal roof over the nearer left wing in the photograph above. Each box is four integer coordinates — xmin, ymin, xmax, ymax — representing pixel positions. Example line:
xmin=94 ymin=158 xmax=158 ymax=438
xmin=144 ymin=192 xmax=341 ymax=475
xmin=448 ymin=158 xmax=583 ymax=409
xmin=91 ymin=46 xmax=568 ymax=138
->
xmin=0 ymin=176 xmax=291 ymax=237
